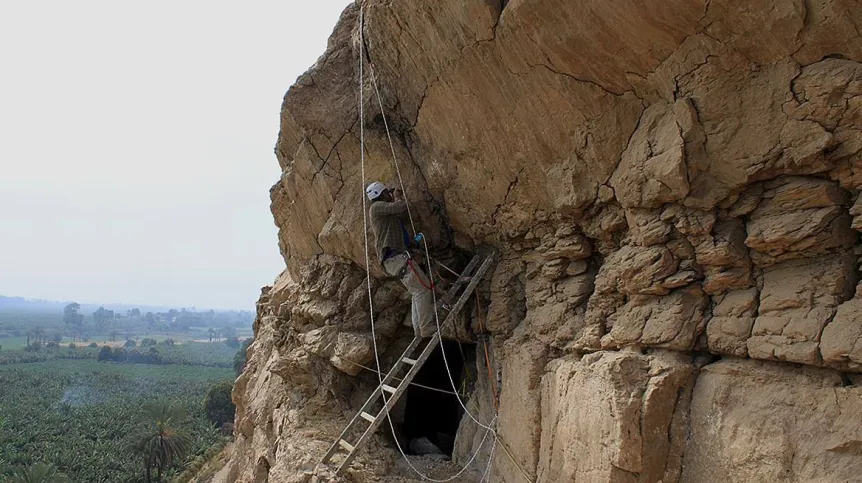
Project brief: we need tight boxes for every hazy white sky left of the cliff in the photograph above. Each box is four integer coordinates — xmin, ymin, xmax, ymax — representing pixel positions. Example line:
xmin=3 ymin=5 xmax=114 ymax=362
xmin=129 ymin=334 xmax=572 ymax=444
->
xmin=0 ymin=0 xmax=350 ymax=308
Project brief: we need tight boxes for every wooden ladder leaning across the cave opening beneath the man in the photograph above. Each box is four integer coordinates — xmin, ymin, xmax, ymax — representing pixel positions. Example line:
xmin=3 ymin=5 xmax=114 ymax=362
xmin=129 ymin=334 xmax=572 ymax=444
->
xmin=311 ymin=253 xmax=494 ymax=483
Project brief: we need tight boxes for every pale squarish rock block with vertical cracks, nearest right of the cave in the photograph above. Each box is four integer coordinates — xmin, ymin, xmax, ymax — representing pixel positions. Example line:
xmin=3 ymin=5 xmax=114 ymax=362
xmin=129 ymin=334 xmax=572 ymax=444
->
xmin=540 ymin=352 xmax=695 ymax=482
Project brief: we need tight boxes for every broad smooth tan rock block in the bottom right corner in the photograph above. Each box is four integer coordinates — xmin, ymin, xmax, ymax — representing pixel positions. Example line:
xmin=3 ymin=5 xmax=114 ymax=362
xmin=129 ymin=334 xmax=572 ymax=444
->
xmin=681 ymin=360 xmax=862 ymax=483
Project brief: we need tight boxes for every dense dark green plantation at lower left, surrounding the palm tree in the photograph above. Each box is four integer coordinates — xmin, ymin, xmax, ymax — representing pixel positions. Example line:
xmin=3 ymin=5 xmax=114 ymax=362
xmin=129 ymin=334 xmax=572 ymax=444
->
xmin=0 ymin=362 xmax=234 ymax=483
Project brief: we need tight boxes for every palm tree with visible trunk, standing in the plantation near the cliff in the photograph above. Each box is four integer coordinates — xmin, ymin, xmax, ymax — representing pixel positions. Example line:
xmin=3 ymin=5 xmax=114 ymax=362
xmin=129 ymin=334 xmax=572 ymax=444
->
xmin=132 ymin=402 xmax=192 ymax=482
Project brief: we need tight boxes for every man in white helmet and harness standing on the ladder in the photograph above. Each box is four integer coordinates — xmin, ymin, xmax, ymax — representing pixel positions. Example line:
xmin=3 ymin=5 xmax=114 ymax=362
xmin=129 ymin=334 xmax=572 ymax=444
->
xmin=365 ymin=181 xmax=435 ymax=337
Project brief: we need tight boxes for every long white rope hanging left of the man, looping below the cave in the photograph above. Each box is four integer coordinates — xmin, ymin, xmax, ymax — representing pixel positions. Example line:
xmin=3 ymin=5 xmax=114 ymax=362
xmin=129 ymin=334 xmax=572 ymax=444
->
xmin=359 ymin=8 xmax=497 ymax=483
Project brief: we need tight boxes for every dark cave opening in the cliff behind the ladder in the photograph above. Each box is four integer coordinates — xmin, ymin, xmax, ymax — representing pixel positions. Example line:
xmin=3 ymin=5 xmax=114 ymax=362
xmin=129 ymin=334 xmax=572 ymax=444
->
xmin=403 ymin=341 xmax=476 ymax=457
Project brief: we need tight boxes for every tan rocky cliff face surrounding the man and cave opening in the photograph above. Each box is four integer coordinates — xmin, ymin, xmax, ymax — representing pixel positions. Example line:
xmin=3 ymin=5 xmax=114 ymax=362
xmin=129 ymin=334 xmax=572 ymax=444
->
xmin=220 ymin=0 xmax=862 ymax=483
